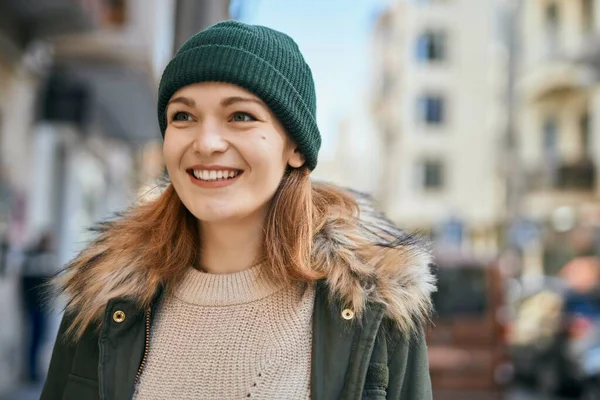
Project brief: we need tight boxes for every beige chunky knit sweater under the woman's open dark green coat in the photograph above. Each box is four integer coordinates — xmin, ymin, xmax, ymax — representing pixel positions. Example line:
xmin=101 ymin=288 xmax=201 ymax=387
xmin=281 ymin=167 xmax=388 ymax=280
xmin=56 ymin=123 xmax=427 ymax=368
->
xmin=134 ymin=266 xmax=315 ymax=400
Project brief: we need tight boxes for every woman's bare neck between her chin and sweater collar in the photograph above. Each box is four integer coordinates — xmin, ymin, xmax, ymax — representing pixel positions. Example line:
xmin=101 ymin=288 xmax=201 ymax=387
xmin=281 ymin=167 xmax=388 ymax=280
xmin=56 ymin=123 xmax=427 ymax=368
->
xmin=200 ymin=212 xmax=264 ymax=274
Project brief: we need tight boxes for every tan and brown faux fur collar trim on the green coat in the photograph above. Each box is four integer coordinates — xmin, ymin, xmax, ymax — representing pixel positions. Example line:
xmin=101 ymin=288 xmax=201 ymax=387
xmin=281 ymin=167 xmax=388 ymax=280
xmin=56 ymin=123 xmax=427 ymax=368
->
xmin=57 ymin=191 xmax=435 ymax=336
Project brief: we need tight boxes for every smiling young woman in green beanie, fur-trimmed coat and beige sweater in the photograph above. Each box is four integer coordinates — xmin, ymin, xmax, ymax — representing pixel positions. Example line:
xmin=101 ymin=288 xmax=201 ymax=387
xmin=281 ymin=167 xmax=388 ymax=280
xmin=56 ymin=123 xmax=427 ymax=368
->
xmin=42 ymin=21 xmax=434 ymax=400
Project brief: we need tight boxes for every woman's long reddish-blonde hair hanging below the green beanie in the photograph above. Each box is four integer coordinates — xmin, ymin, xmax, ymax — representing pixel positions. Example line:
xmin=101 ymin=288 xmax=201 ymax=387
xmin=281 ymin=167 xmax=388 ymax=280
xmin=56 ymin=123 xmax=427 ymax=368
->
xmin=137 ymin=168 xmax=358 ymax=282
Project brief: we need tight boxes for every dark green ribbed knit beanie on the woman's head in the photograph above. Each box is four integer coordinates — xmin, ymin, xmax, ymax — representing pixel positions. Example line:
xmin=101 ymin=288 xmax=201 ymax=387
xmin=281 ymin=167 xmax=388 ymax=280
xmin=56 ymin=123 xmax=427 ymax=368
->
xmin=158 ymin=21 xmax=321 ymax=170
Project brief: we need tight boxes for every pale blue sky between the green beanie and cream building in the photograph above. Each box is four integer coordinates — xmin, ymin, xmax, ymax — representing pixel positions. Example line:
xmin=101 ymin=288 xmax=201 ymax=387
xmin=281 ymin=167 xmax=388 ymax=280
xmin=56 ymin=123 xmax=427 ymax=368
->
xmin=231 ymin=0 xmax=393 ymax=157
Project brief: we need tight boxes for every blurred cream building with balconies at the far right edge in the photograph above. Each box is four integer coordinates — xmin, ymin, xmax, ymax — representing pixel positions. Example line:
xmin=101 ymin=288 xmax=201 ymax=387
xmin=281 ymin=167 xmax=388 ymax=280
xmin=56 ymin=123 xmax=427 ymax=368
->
xmin=516 ymin=0 xmax=600 ymax=273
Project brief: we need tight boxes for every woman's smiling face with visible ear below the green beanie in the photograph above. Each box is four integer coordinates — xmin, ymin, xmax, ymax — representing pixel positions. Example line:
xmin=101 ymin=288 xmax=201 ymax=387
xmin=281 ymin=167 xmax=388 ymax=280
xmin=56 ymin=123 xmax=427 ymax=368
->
xmin=163 ymin=82 xmax=304 ymax=222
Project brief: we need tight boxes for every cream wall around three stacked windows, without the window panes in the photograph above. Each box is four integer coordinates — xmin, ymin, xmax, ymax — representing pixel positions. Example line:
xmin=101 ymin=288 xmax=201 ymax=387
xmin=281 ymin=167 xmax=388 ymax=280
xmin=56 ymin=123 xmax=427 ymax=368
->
xmin=390 ymin=0 xmax=502 ymax=226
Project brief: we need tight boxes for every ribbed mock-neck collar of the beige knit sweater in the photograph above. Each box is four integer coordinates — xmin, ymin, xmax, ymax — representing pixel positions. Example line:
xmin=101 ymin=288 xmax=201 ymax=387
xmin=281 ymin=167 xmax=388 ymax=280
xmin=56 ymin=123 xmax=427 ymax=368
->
xmin=175 ymin=264 xmax=285 ymax=306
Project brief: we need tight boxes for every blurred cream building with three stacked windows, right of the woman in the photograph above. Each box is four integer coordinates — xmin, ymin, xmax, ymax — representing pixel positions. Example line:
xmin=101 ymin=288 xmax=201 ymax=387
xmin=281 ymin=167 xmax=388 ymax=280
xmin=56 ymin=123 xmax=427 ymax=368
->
xmin=372 ymin=0 xmax=505 ymax=253
